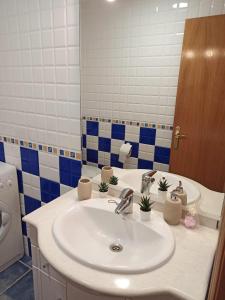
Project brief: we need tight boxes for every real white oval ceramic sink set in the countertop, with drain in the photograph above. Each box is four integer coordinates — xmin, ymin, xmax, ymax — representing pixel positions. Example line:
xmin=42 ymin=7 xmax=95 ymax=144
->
xmin=53 ymin=199 xmax=175 ymax=274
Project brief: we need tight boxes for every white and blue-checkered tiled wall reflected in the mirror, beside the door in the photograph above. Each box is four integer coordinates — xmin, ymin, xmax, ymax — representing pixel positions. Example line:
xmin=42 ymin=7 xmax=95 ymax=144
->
xmin=81 ymin=0 xmax=225 ymax=170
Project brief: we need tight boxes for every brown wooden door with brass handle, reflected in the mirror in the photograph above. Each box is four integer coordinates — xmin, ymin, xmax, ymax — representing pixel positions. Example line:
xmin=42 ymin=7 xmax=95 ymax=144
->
xmin=170 ymin=15 xmax=225 ymax=192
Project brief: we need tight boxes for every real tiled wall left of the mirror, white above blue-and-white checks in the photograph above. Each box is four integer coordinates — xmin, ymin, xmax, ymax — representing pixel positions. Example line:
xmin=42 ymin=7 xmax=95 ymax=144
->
xmin=0 ymin=0 xmax=81 ymax=253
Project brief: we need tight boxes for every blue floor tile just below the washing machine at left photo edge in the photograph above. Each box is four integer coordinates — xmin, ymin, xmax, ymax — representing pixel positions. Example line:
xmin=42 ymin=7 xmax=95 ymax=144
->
xmin=0 ymin=262 xmax=29 ymax=299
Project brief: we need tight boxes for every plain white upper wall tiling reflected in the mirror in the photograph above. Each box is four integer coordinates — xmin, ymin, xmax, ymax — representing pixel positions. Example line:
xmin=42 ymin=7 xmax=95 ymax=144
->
xmin=80 ymin=0 xmax=224 ymax=132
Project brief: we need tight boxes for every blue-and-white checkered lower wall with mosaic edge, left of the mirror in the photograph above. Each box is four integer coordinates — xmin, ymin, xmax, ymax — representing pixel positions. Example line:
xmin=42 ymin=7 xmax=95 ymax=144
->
xmin=0 ymin=136 xmax=82 ymax=255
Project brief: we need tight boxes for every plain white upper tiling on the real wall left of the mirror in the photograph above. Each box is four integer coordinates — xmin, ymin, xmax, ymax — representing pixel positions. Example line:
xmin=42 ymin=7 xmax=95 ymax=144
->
xmin=0 ymin=0 xmax=80 ymax=151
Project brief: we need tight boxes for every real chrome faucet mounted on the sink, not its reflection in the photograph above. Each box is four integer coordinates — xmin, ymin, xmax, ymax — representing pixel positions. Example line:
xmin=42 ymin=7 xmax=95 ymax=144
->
xmin=115 ymin=188 xmax=134 ymax=214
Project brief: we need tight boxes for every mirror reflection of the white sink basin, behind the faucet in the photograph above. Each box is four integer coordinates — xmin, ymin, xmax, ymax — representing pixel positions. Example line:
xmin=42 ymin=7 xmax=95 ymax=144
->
xmin=119 ymin=169 xmax=200 ymax=204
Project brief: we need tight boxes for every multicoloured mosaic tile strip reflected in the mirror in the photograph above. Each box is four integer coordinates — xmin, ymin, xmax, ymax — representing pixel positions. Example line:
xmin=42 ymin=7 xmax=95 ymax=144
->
xmin=82 ymin=116 xmax=173 ymax=131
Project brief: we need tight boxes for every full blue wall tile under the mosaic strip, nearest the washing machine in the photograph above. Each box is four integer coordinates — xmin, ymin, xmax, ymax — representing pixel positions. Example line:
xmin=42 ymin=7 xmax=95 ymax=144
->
xmin=20 ymin=147 xmax=39 ymax=176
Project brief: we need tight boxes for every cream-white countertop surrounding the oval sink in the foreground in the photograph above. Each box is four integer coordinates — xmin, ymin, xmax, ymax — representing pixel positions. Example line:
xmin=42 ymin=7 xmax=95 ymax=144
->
xmin=23 ymin=189 xmax=218 ymax=300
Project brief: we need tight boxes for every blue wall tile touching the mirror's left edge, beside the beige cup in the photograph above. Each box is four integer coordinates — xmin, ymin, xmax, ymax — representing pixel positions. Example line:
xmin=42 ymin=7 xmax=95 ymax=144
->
xmin=59 ymin=156 xmax=81 ymax=187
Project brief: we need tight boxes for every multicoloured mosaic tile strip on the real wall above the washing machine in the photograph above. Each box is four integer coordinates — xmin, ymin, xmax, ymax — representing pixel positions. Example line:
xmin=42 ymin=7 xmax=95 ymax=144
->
xmin=0 ymin=136 xmax=81 ymax=160
